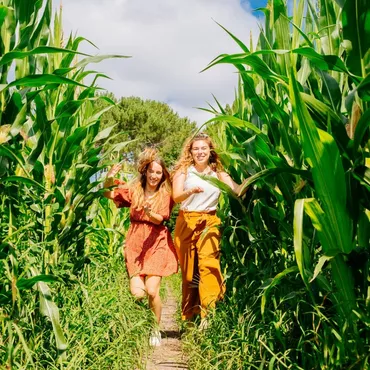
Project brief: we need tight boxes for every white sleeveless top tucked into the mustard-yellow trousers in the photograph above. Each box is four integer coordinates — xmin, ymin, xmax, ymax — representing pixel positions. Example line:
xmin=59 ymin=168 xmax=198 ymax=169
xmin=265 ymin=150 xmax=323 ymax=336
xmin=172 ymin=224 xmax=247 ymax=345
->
xmin=180 ymin=166 xmax=220 ymax=212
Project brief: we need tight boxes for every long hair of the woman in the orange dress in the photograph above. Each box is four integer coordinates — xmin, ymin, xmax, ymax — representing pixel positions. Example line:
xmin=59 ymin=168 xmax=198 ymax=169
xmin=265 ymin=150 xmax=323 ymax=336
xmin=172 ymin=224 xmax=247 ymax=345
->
xmin=129 ymin=148 xmax=171 ymax=212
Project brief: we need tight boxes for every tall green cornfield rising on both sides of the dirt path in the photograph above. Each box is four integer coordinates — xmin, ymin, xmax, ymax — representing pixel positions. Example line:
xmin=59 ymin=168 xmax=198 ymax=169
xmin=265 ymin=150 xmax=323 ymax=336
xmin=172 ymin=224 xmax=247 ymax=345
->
xmin=0 ymin=0 xmax=370 ymax=370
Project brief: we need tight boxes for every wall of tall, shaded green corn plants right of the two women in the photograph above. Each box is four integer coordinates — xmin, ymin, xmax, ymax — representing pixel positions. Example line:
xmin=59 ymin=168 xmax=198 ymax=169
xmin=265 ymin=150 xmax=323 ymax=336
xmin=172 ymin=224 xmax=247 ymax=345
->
xmin=201 ymin=0 xmax=370 ymax=369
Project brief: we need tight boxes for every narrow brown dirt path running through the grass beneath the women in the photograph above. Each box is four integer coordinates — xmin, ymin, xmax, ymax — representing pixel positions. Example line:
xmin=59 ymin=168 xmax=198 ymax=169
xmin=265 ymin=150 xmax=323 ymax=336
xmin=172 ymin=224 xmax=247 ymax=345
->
xmin=146 ymin=285 xmax=188 ymax=370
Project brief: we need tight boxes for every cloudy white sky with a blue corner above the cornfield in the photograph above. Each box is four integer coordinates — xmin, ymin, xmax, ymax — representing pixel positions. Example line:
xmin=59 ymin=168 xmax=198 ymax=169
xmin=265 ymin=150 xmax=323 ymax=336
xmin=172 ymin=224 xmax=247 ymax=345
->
xmin=59 ymin=0 xmax=266 ymax=125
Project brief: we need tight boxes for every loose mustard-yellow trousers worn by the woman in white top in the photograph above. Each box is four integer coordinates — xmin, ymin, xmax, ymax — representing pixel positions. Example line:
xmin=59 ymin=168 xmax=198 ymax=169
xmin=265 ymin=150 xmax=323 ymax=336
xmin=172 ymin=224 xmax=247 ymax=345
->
xmin=174 ymin=211 xmax=225 ymax=320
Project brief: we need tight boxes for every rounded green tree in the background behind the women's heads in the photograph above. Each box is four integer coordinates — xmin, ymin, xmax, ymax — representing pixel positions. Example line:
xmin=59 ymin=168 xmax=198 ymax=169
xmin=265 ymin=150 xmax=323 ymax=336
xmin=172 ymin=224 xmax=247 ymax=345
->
xmin=99 ymin=94 xmax=196 ymax=166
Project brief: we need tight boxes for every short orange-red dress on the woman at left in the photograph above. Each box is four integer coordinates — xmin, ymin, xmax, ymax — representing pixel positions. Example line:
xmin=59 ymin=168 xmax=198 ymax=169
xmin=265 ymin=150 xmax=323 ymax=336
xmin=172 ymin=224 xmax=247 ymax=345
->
xmin=113 ymin=182 xmax=178 ymax=277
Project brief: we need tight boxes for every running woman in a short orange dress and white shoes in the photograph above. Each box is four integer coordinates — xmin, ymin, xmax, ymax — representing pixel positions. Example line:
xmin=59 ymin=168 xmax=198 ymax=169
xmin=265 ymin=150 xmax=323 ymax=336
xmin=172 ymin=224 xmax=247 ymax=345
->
xmin=104 ymin=149 xmax=178 ymax=346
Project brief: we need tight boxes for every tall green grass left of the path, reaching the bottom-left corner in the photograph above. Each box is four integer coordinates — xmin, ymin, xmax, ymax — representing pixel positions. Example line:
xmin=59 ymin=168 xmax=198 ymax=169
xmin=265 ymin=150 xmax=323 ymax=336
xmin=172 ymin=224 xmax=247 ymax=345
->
xmin=0 ymin=255 xmax=154 ymax=370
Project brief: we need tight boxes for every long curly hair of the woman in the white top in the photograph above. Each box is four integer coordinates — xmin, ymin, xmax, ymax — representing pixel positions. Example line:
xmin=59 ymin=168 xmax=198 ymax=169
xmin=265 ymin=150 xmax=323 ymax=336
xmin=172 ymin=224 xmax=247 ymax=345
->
xmin=171 ymin=132 xmax=224 ymax=177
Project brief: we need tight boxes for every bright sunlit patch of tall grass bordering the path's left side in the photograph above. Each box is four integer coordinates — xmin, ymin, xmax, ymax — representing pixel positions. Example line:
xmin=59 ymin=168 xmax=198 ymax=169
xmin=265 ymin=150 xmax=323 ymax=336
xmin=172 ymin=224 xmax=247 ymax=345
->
xmin=56 ymin=255 xmax=154 ymax=370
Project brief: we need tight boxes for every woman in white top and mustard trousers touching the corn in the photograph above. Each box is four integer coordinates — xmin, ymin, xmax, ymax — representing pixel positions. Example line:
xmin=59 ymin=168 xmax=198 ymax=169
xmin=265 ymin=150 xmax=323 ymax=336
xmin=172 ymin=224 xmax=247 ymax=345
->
xmin=173 ymin=133 xmax=247 ymax=326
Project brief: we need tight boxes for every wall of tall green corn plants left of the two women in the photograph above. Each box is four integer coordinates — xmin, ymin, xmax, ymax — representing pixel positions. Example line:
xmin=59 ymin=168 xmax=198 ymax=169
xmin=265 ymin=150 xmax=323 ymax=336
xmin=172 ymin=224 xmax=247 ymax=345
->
xmin=0 ymin=0 xmax=124 ymax=368
